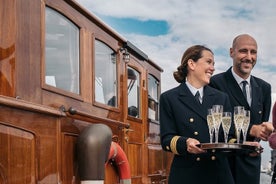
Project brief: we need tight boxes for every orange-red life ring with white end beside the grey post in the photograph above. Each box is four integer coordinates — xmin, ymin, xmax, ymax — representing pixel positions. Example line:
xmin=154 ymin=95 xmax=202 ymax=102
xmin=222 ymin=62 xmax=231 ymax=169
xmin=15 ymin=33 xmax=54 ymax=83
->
xmin=108 ymin=141 xmax=131 ymax=184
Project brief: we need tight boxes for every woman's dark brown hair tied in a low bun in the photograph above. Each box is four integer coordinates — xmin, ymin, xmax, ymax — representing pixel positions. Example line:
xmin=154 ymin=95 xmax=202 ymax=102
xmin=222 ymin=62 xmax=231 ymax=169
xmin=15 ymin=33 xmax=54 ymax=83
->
xmin=173 ymin=45 xmax=214 ymax=83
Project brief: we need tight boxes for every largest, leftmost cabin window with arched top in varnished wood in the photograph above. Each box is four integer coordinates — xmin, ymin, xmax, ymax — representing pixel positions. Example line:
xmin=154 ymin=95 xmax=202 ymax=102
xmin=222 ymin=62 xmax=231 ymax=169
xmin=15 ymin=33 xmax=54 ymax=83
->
xmin=45 ymin=7 xmax=80 ymax=94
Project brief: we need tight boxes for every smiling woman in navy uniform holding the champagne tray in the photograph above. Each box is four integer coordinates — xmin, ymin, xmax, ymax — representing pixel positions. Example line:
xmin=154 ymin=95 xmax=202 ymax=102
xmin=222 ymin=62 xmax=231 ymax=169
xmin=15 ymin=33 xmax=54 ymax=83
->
xmin=160 ymin=45 xmax=234 ymax=184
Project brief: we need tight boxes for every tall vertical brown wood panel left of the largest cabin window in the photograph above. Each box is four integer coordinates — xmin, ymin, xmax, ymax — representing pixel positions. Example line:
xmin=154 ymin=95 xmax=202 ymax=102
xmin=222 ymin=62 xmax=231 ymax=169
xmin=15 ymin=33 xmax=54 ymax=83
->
xmin=15 ymin=0 xmax=44 ymax=101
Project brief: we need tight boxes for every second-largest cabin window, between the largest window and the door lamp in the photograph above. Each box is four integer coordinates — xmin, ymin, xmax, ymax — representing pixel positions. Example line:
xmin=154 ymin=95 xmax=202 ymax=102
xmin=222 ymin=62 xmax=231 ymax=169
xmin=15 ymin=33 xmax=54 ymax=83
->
xmin=95 ymin=40 xmax=117 ymax=107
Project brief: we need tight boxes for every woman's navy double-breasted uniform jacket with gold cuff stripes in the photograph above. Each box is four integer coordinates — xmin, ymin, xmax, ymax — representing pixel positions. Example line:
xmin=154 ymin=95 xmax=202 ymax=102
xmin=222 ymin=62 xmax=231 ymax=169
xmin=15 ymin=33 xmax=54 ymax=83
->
xmin=160 ymin=83 xmax=233 ymax=184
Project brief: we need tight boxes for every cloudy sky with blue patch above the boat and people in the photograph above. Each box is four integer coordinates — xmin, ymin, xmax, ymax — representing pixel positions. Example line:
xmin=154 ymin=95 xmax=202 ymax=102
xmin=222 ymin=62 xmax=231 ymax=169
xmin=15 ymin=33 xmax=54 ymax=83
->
xmin=77 ymin=0 xmax=276 ymax=166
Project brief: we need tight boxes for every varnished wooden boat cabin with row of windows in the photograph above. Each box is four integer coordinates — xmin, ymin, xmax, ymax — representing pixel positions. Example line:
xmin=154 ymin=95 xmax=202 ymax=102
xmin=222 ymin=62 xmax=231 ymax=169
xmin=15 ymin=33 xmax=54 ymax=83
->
xmin=0 ymin=0 xmax=171 ymax=184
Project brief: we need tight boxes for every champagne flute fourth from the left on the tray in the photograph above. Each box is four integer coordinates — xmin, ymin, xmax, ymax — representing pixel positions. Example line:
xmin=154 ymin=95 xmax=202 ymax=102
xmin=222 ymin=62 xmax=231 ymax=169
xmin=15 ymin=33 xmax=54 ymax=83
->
xmin=234 ymin=106 xmax=244 ymax=143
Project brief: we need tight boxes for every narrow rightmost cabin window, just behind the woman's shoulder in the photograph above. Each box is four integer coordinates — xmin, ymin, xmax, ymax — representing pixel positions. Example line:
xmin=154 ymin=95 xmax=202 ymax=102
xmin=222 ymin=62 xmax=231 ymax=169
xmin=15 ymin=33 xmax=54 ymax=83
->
xmin=148 ymin=75 xmax=159 ymax=121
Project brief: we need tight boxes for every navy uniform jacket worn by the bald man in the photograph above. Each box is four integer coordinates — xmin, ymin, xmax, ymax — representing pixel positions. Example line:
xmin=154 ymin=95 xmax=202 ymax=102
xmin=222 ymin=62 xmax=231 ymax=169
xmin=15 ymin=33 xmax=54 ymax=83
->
xmin=210 ymin=68 xmax=271 ymax=184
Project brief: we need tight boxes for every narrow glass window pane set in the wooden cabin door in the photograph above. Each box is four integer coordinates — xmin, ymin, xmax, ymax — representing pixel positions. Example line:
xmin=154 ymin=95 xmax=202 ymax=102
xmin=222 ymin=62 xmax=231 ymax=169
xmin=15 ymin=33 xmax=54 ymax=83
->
xmin=127 ymin=67 xmax=140 ymax=118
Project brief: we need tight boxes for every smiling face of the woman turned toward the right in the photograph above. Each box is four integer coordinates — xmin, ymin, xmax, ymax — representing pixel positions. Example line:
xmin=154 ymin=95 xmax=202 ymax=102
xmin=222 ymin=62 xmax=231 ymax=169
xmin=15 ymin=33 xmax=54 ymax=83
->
xmin=191 ymin=50 xmax=215 ymax=88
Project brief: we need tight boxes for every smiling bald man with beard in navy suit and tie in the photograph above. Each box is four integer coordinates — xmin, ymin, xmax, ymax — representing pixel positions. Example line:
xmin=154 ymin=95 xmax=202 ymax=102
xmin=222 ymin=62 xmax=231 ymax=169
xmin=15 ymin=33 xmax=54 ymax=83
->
xmin=210 ymin=34 xmax=273 ymax=184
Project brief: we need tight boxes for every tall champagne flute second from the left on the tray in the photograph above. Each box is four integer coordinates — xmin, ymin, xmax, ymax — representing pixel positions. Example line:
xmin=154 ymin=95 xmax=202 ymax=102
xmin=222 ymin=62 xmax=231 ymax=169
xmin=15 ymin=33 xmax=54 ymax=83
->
xmin=212 ymin=105 xmax=223 ymax=143
